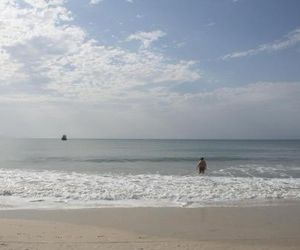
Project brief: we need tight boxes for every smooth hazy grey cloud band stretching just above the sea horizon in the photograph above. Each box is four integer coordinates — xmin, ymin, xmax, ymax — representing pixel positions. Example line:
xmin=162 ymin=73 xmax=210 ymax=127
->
xmin=0 ymin=82 xmax=300 ymax=139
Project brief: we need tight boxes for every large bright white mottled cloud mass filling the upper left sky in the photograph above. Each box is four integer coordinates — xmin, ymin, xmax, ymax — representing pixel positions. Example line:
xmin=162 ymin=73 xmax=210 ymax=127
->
xmin=0 ymin=0 xmax=200 ymax=102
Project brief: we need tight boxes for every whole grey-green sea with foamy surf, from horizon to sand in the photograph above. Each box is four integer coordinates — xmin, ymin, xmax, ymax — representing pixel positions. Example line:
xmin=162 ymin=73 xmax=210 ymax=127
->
xmin=0 ymin=139 xmax=300 ymax=209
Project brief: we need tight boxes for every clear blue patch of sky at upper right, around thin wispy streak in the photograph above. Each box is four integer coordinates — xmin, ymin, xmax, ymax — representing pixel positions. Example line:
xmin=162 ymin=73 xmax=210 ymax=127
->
xmin=70 ymin=0 xmax=300 ymax=83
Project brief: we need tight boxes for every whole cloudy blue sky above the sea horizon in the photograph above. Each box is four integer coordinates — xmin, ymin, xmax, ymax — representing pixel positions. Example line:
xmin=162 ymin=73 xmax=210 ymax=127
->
xmin=0 ymin=0 xmax=300 ymax=139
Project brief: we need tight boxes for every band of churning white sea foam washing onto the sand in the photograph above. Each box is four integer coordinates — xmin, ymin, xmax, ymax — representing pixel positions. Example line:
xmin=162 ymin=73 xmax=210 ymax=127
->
xmin=0 ymin=169 xmax=300 ymax=209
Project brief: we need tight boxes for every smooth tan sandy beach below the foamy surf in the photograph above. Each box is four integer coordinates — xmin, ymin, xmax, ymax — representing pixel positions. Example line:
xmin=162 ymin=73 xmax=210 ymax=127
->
xmin=0 ymin=203 xmax=300 ymax=250
